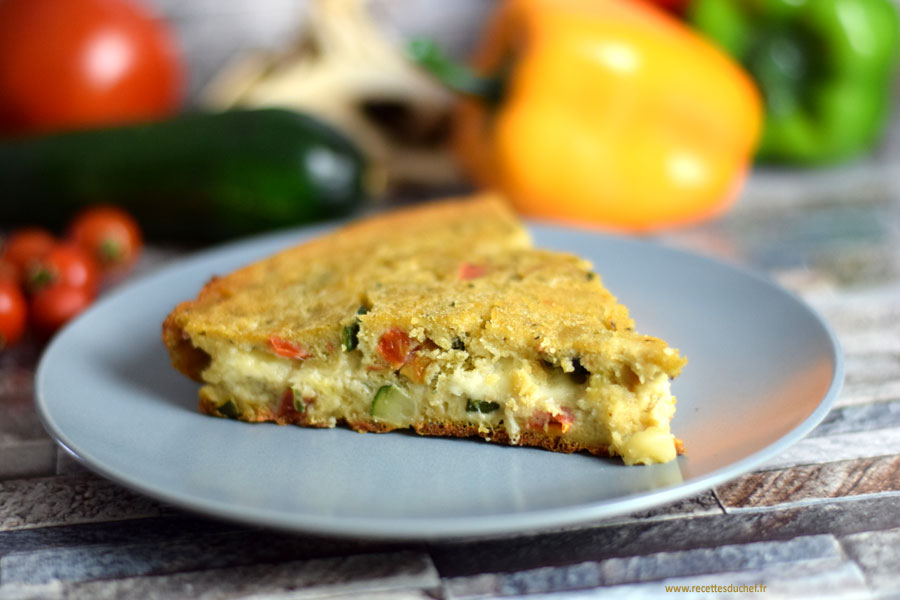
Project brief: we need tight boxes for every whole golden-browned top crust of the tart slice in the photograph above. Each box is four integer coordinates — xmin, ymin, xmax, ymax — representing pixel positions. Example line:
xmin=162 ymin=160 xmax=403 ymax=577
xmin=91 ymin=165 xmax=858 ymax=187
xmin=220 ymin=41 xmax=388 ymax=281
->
xmin=163 ymin=192 xmax=684 ymax=379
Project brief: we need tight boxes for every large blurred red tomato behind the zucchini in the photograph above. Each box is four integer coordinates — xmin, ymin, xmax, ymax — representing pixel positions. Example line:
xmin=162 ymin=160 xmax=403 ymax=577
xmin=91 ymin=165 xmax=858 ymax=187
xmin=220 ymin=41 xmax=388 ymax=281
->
xmin=0 ymin=0 xmax=182 ymax=133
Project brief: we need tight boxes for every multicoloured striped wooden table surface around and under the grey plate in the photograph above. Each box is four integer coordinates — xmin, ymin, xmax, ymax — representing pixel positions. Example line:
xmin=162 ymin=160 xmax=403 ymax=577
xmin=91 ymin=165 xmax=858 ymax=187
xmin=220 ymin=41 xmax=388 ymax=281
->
xmin=0 ymin=143 xmax=900 ymax=600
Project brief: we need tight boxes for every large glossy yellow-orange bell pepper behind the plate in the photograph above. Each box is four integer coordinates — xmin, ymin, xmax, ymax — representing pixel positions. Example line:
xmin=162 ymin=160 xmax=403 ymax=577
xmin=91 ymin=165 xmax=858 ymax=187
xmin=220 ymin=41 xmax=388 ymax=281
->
xmin=414 ymin=0 xmax=762 ymax=231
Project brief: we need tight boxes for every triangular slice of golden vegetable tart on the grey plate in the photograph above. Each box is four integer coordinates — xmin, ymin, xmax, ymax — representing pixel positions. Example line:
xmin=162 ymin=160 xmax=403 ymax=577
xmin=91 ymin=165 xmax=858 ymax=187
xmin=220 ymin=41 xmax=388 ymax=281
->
xmin=163 ymin=195 xmax=686 ymax=464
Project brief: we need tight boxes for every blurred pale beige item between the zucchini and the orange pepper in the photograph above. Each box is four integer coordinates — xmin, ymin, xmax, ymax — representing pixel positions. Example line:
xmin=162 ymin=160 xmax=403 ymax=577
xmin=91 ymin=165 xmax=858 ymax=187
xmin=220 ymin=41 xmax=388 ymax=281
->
xmin=200 ymin=0 xmax=460 ymax=189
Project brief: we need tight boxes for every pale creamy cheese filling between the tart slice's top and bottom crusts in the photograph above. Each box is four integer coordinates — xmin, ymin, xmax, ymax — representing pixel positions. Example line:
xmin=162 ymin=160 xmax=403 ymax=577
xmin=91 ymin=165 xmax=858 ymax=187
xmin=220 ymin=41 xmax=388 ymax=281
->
xmin=195 ymin=339 xmax=676 ymax=464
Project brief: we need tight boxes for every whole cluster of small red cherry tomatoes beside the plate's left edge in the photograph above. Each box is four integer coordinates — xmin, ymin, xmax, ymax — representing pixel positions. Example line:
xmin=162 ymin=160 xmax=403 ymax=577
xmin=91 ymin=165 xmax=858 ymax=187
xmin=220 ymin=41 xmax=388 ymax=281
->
xmin=0 ymin=206 xmax=143 ymax=350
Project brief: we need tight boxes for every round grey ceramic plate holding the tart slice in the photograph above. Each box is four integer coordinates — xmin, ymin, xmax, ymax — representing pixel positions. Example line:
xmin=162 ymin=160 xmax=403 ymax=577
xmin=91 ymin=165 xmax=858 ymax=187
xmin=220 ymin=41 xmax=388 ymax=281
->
xmin=36 ymin=220 xmax=842 ymax=539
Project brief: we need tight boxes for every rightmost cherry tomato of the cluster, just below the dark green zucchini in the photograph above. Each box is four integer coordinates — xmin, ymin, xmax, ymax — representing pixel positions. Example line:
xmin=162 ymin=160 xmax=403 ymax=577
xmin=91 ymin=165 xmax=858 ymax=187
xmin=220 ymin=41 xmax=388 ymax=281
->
xmin=69 ymin=206 xmax=142 ymax=275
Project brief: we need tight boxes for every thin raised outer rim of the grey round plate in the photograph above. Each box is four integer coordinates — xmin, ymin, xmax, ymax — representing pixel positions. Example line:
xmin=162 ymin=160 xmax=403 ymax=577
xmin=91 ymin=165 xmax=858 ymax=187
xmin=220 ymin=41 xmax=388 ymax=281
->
xmin=34 ymin=220 xmax=845 ymax=541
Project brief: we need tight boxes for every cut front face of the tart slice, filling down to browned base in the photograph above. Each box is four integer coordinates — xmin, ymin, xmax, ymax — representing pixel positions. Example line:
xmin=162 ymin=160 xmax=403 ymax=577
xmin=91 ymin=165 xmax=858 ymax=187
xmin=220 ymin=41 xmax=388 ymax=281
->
xmin=194 ymin=318 xmax=677 ymax=464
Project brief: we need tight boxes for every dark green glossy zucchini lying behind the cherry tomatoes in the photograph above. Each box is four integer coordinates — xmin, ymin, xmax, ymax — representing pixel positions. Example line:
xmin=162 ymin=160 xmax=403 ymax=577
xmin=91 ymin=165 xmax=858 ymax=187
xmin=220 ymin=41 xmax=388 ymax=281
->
xmin=0 ymin=109 xmax=372 ymax=242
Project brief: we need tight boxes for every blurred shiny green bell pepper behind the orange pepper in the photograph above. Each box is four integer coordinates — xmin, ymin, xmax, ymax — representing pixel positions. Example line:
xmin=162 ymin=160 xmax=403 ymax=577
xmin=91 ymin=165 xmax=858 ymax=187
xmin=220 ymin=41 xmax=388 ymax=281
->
xmin=687 ymin=0 xmax=900 ymax=165
